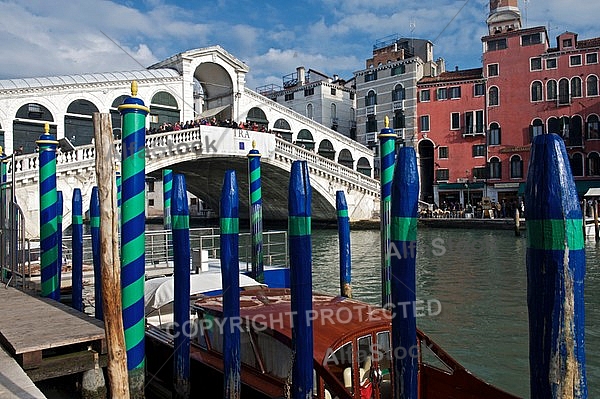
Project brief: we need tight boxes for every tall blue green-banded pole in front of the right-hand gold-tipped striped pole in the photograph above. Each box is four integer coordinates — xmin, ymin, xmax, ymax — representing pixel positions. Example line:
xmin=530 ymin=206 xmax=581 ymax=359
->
xmin=390 ymin=147 xmax=419 ymax=399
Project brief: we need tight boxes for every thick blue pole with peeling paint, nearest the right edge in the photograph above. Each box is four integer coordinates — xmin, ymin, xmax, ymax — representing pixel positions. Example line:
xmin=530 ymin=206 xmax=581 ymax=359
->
xmin=525 ymin=134 xmax=587 ymax=399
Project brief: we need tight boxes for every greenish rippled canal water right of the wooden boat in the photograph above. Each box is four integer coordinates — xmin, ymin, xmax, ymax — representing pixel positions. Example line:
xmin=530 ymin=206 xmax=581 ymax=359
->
xmin=312 ymin=229 xmax=600 ymax=398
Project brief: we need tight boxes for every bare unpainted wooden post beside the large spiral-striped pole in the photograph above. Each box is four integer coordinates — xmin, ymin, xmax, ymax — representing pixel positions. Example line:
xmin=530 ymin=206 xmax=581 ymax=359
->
xmin=92 ymin=112 xmax=129 ymax=398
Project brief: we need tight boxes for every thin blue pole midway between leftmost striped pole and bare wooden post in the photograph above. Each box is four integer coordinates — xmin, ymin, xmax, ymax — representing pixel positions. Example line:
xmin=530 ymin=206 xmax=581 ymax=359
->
xmin=71 ymin=188 xmax=83 ymax=312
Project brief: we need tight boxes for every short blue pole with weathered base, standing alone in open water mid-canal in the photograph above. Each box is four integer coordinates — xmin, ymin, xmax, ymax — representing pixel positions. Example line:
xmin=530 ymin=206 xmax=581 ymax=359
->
xmin=335 ymin=190 xmax=352 ymax=298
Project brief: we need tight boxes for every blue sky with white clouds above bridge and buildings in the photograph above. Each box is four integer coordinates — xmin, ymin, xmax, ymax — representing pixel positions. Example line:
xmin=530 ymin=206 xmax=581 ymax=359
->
xmin=0 ymin=0 xmax=600 ymax=89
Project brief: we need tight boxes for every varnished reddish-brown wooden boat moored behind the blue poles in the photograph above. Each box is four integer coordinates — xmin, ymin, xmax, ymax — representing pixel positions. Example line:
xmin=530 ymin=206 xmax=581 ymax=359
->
xmin=146 ymin=289 xmax=516 ymax=399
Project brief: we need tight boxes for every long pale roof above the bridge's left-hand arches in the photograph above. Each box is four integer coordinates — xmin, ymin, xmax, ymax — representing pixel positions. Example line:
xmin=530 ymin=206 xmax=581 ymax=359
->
xmin=0 ymin=68 xmax=180 ymax=90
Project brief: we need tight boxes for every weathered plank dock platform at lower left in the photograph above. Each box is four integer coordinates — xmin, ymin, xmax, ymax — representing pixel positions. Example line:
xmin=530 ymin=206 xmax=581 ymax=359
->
xmin=0 ymin=286 xmax=106 ymax=384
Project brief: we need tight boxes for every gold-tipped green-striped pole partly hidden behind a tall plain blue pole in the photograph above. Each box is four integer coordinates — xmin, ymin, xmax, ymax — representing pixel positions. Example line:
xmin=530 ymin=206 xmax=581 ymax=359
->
xmin=379 ymin=116 xmax=396 ymax=307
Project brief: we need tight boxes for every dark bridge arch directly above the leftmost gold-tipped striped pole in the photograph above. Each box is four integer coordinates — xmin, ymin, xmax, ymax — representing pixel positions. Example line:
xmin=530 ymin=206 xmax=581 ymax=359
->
xmin=13 ymin=103 xmax=56 ymax=154
